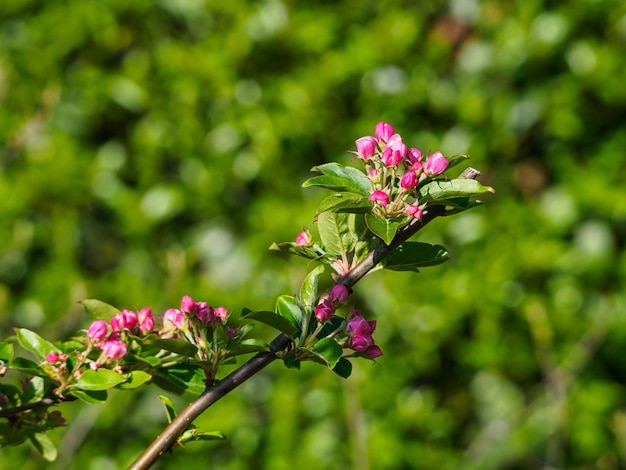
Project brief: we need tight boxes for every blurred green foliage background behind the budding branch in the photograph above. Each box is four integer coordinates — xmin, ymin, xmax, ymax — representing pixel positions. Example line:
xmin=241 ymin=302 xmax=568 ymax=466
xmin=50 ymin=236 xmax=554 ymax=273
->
xmin=0 ymin=0 xmax=626 ymax=470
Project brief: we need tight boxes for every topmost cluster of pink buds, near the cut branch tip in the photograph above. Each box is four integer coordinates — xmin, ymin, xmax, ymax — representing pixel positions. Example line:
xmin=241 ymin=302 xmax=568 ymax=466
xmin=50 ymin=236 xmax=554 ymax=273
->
xmin=355 ymin=122 xmax=449 ymax=219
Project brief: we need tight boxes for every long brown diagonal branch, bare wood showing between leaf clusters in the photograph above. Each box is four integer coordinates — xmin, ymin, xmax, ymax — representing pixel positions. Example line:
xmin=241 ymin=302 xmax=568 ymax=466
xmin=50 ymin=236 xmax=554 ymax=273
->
xmin=129 ymin=169 xmax=480 ymax=470
